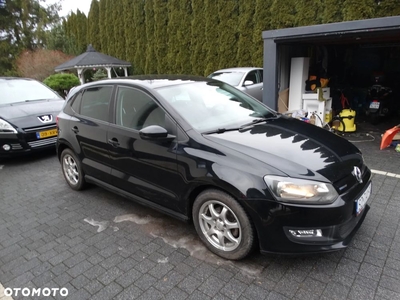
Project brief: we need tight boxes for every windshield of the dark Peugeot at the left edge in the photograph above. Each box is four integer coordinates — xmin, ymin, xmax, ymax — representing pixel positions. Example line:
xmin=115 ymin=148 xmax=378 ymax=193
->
xmin=0 ymin=79 xmax=60 ymax=105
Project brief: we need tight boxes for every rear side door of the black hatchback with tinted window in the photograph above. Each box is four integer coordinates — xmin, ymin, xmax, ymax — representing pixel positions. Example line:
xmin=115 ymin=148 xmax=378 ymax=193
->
xmin=69 ymin=85 xmax=113 ymax=183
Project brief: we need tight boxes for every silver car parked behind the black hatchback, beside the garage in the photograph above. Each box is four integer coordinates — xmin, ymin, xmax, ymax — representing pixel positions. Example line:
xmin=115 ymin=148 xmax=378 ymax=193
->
xmin=208 ymin=67 xmax=263 ymax=101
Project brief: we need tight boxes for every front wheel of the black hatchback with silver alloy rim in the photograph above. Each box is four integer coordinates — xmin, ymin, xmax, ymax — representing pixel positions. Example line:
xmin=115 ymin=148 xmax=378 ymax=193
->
xmin=192 ymin=190 xmax=254 ymax=260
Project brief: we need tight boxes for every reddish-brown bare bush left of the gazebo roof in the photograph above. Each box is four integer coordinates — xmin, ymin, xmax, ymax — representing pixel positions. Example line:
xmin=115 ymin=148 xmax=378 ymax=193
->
xmin=16 ymin=49 xmax=73 ymax=81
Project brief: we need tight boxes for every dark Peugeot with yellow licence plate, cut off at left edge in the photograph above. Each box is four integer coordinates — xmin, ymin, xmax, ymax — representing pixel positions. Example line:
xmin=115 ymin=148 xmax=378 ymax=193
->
xmin=0 ymin=77 xmax=65 ymax=156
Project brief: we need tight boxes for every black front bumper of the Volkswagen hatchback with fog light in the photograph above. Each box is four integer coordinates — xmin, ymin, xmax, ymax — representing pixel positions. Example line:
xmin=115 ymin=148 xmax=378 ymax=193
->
xmin=244 ymin=180 xmax=370 ymax=255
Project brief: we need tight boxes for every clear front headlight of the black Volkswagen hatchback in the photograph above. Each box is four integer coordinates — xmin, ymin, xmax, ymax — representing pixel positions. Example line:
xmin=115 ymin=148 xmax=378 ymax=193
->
xmin=264 ymin=175 xmax=339 ymax=204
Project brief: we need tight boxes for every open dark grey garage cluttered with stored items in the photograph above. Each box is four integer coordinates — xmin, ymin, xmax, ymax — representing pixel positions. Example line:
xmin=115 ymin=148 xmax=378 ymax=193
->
xmin=262 ymin=16 xmax=400 ymax=127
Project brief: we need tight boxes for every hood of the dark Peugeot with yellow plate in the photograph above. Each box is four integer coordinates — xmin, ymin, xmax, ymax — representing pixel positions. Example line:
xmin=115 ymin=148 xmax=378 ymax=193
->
xmin=0 ymin=99 xmax=64 ymax=128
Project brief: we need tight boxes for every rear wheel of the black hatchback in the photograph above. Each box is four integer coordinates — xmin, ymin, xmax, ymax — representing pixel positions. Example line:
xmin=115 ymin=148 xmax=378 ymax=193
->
xmin=61 ymin=149 xmax=86 ymax=191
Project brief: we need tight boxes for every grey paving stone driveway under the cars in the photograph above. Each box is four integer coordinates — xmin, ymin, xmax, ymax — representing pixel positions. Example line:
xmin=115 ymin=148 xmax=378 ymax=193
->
xmin=0 ymin=120 xmax=400 ymax=300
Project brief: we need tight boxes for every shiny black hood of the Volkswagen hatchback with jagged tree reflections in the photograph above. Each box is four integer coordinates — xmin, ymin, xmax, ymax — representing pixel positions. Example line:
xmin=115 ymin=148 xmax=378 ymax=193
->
xmin=204 ymin=117 xmax=363 ymax=182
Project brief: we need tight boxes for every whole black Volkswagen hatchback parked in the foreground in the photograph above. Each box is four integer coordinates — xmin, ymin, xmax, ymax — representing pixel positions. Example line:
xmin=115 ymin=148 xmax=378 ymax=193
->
xmin=57 ymin=76 xmax=371 ymax=260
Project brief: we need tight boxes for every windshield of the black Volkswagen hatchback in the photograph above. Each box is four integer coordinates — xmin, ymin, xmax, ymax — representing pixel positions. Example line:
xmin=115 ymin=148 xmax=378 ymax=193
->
xmin=158 ymin=81 xmax=276 ymax=133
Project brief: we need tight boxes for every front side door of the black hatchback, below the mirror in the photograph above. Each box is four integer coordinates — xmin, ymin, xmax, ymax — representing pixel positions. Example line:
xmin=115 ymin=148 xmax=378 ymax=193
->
xmin=107 ymin=86 xmax=179 ymax=210
